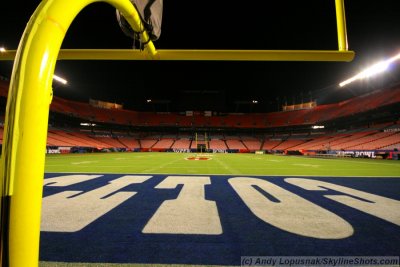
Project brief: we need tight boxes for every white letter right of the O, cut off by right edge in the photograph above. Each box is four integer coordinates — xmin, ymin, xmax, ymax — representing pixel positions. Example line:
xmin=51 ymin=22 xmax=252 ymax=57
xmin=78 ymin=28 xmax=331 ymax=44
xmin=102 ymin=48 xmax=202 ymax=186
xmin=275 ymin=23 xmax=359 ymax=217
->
xmin=285 ymin=178 xmax=400 ymax=225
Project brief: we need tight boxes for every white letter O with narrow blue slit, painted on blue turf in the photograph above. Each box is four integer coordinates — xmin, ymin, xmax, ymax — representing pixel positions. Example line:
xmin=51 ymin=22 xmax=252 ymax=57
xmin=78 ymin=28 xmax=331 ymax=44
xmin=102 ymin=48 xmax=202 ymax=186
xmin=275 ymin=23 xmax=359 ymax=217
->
xmin=228 ymin=177 xmax=353 ymax=239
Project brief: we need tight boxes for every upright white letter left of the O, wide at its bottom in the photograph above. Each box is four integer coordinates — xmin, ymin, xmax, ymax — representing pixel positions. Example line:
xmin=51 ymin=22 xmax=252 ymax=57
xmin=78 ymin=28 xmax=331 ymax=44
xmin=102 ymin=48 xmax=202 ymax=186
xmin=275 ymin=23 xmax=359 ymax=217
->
xmin=142 ymin=176 xmax=222 ymax=235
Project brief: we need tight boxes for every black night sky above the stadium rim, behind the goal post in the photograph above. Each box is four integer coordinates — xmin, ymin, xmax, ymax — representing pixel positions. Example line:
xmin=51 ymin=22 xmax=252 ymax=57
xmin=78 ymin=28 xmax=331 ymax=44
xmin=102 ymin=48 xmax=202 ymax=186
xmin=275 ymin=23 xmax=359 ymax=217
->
xmin=0 ymin=0 xmax=400 ymax=112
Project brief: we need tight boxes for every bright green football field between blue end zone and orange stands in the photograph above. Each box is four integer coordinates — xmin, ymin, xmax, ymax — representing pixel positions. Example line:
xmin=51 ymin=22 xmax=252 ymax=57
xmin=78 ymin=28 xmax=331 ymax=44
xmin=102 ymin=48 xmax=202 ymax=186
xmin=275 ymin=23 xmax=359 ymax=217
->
xmin=45 ymin=152 xmax=400 ymax=177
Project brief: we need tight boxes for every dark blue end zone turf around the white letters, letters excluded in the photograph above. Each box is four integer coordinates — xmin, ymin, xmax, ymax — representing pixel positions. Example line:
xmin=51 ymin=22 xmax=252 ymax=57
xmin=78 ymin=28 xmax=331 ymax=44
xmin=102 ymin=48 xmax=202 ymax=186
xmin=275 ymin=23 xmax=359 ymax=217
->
xmin=40 ymin=174 xmax=400 ymax=265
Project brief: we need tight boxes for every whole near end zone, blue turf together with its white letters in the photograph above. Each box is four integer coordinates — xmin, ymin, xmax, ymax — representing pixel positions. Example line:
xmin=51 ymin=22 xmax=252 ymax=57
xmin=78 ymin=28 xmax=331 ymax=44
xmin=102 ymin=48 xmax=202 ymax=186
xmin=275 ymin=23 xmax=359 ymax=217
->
xmin=40 ymin=174 xmax=400 ymax=265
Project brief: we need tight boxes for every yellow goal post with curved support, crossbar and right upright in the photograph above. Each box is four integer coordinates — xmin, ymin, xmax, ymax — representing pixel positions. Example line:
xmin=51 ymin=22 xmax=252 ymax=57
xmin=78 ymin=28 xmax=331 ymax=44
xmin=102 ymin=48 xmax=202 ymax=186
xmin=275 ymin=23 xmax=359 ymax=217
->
xmin=0 ymin=0 xmax=354 ymax=267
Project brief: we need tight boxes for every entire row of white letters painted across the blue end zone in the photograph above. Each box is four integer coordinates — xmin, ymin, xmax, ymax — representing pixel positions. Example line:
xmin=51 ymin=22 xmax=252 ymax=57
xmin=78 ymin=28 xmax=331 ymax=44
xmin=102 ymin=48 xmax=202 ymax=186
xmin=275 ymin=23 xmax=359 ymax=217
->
xmin=42 ymin=174 xmax=400 ymax=239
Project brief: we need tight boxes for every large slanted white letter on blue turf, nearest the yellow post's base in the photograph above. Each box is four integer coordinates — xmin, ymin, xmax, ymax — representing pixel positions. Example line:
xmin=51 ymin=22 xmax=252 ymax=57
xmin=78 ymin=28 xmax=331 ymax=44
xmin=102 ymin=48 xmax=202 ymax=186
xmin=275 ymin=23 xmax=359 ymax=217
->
xmin=41 ymin=175 xmax=152 ymax=232
